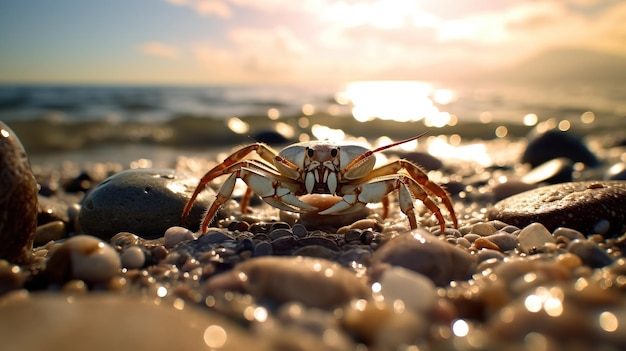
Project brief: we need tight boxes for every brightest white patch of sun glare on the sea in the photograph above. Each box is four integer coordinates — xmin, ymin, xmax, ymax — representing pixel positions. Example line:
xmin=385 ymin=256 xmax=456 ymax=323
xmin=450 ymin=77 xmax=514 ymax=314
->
xmin=335 ymin=81 xmax=455 ymax=127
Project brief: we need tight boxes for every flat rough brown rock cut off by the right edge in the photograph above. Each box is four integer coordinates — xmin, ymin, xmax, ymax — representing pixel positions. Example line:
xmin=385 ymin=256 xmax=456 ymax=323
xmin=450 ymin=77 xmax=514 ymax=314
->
xmin=489 ymin=181 xmax=626 ymax=235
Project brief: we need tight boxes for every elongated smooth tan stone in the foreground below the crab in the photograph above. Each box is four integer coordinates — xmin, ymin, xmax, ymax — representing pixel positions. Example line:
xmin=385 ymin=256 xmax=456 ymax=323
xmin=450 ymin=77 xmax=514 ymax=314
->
xmin=204 ymin=256 xmax=369 ymax=308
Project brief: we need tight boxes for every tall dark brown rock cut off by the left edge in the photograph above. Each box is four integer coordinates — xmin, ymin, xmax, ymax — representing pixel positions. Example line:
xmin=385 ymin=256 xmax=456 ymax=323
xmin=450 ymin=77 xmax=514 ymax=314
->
xmin=0 ymin=122 xmax=38 ymax=263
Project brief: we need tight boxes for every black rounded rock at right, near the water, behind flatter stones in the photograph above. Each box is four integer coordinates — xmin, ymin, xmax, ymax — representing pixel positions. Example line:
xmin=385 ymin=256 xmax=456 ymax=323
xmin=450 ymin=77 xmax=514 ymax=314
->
xmin=522 ymin=130 xmax=600 ymax=167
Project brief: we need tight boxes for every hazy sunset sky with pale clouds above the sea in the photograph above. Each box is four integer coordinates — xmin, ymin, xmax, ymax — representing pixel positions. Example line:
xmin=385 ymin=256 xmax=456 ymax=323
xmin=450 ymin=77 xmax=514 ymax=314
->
xmin=0 ymin=0 xmax=626 ymax=84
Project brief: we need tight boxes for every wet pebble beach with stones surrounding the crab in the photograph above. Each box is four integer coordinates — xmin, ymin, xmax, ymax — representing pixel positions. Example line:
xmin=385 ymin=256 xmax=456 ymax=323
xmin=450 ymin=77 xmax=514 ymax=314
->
xmin=0 ymin=84 xmax=626 ymax=351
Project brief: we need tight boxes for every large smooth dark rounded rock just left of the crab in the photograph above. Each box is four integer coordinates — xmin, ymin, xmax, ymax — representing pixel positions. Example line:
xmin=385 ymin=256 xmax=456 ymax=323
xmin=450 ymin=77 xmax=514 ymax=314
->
xmin=79 ymin=169 xmax=209 ymax=239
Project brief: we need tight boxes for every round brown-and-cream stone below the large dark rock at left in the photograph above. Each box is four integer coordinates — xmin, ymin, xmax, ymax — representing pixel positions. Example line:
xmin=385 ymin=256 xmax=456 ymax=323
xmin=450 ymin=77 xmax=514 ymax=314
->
xmin=46 ymin=235 xmax=121 ymax=284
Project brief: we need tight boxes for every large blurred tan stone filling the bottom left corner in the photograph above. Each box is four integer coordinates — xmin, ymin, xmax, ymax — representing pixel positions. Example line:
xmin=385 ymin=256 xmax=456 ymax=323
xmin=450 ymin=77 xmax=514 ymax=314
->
xmin=0 ymin=293 xmax=266 ymax=351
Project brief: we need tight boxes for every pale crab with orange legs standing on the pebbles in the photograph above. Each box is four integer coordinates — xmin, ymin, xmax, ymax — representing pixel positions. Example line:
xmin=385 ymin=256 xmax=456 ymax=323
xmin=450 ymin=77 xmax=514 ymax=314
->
xmin=182 ymin=133 xmax=458 ymax=233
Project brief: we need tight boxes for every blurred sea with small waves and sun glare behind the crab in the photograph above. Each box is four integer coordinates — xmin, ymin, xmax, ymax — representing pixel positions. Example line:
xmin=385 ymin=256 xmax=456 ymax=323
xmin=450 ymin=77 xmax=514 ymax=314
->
xmin=0 ymin=81 xmax=626 ymax=167
